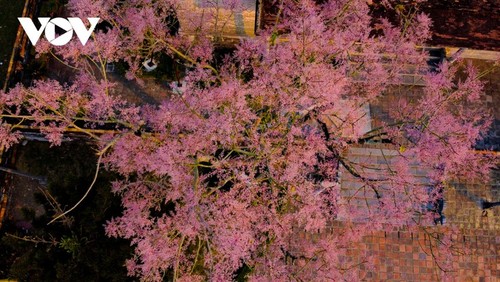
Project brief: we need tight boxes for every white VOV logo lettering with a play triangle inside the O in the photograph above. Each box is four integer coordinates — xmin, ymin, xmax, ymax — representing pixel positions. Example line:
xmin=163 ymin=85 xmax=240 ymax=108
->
xmin=17 ymin=18 xmax=99 ymax=46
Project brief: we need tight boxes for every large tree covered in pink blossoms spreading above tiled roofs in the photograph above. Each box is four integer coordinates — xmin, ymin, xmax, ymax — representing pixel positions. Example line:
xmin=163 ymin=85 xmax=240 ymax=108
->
xmin=0 ymin=0 xmax=493 ymax=281
